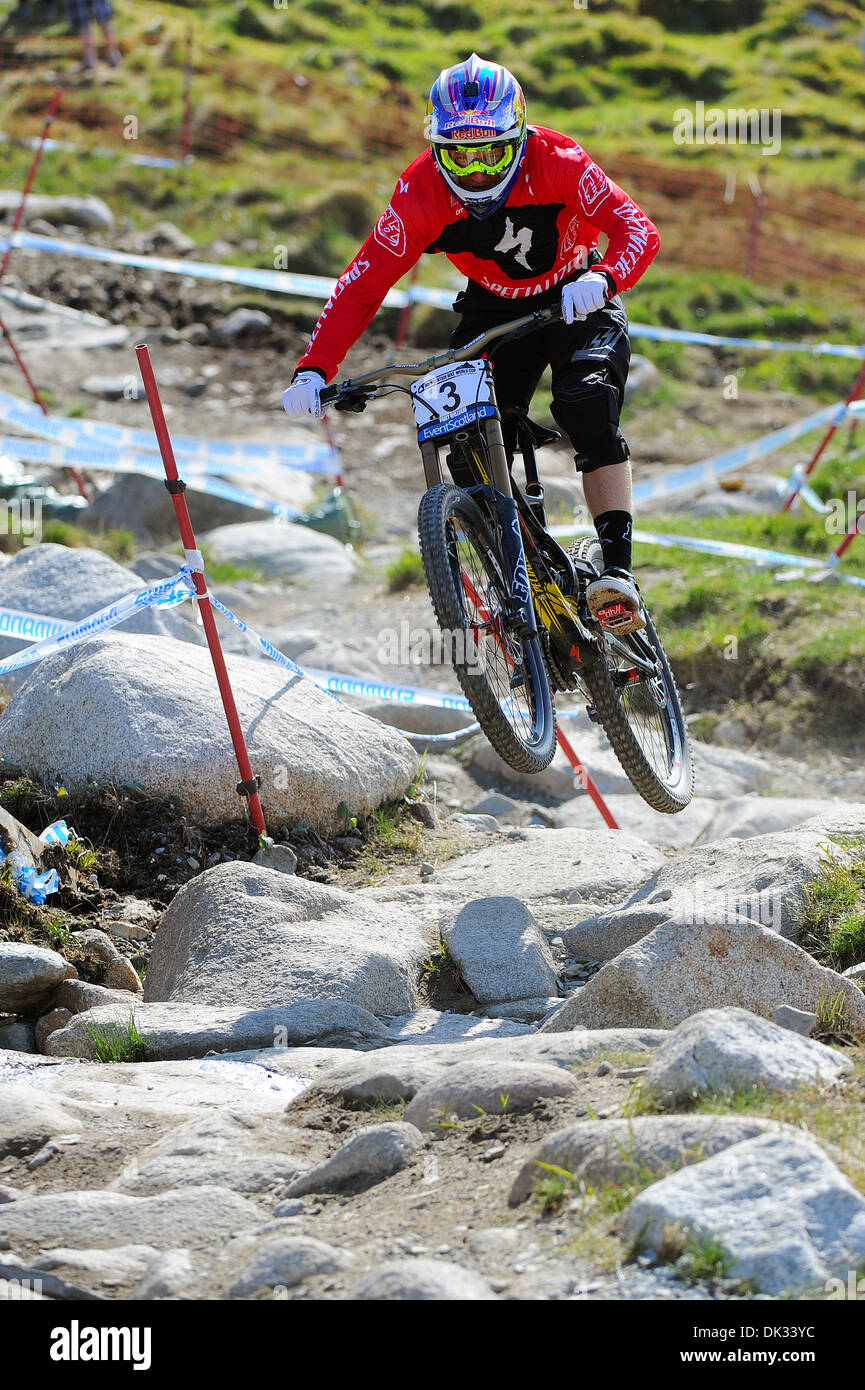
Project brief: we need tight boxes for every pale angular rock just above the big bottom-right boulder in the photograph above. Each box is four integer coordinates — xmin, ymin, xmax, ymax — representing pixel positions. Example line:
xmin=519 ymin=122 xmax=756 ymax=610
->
xmin=642 ymin=1009 xmax=852 ymax=1109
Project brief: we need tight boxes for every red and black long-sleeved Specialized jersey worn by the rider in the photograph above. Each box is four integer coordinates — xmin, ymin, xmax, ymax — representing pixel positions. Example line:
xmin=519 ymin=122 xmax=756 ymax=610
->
xmin=298 ymin=125 xmax=661 ymax=381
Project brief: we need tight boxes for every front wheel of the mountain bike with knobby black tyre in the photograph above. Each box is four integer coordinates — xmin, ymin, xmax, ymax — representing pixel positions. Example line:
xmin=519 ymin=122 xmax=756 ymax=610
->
xmin=417 ymin=482 xmax=556 ymax=773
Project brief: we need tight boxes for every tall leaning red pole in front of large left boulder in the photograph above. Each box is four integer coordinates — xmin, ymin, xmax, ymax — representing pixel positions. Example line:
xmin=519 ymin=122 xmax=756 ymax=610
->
xmin=135 ymin=343 xmax=267 ymax=835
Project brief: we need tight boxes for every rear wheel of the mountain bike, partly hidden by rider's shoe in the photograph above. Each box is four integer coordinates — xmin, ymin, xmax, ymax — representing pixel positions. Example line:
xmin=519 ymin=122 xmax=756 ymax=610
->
xmin=570 ymin=537 xmax=694 ymax=815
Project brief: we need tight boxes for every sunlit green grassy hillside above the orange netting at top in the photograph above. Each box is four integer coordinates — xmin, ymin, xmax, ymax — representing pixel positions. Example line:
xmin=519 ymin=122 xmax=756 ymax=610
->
xmin=6 ymin=0 xmax=865 ymax=182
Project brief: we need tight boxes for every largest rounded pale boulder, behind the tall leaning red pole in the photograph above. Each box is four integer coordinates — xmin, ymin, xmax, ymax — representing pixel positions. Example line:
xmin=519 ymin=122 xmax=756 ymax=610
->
xmin=0 ymin=636 xmax=417 ymax=833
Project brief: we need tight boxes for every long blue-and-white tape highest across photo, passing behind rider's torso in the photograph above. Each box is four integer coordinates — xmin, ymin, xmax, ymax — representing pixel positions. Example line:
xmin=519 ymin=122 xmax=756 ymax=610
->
xmin=0 ymin=232 xmax=865 ymax=360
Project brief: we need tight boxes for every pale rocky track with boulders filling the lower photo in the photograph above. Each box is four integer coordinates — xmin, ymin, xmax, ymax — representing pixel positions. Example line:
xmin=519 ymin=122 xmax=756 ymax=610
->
xmin=0 ymin=201 xmax=865 ymax=1300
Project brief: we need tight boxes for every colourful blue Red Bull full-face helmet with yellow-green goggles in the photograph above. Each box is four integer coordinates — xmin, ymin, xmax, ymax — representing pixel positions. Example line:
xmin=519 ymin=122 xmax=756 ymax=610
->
xmin=424 ymin=53 xmax=526 ymax=218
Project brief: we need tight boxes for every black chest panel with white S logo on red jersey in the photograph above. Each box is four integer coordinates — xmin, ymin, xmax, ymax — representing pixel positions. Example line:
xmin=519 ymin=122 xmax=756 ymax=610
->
xmin=428 ymin=203 xmax=565 ymax=279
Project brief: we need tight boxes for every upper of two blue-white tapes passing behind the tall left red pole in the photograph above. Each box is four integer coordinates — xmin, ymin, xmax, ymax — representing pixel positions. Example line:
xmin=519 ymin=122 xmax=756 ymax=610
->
xmin=0 ymin=391 xmax=339 ymax=473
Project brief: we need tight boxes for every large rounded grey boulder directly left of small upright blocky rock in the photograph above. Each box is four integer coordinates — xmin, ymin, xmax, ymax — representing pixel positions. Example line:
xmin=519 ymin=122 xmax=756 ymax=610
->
xmin=146 ymin=861 xmax=428 ymax=1015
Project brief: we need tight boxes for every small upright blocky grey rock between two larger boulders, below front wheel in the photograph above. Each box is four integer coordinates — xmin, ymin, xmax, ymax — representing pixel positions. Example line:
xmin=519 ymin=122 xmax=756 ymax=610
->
xmin=441 ymin=897 xmax=558 ymax=1004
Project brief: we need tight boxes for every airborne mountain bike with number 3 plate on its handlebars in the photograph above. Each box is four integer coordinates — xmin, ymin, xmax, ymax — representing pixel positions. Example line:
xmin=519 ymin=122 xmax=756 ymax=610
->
xmin=321 ymin=298 xmax=693 ymax=813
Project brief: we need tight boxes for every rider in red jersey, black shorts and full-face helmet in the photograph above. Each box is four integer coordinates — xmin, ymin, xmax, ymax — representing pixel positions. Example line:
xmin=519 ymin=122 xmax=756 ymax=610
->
xmin=282 ymin=53 xmax=661 ymax=632
